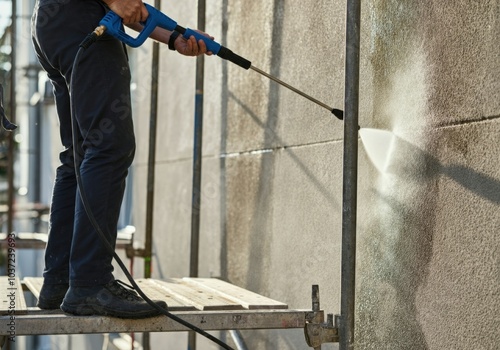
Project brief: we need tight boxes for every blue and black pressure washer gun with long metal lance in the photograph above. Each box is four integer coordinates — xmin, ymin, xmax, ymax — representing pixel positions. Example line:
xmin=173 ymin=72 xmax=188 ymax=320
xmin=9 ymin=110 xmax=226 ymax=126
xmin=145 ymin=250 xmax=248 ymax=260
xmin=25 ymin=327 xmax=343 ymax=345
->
xmin=86 ymin=4 xmax=344 ymax=120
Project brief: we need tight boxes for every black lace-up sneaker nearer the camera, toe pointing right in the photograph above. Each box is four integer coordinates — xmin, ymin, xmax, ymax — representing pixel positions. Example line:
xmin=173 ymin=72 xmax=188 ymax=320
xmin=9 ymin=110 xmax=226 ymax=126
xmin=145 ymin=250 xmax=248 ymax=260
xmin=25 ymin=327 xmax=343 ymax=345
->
xmin=61 ymin=280 xmax=167 ymax=318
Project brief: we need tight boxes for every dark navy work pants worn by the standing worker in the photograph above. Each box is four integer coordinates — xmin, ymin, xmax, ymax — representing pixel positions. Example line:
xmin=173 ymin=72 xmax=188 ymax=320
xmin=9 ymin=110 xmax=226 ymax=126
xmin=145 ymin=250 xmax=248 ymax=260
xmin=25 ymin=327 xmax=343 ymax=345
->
xmin=32 ymin=0 xmax=135 ymax=286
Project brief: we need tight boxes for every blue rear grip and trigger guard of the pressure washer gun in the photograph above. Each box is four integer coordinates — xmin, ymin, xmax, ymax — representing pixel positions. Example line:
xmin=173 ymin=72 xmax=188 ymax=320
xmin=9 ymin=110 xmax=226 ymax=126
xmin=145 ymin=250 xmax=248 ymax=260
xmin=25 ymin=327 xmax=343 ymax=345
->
xmin=99 ymin=3 xmax=177 ymax=47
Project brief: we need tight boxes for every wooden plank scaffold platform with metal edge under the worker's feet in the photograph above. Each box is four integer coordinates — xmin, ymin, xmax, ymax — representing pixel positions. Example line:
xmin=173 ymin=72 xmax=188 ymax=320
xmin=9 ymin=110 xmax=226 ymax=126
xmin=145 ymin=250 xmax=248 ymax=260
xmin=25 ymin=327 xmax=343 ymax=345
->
xmin=0 ymin=276 xmax=316 ymax=336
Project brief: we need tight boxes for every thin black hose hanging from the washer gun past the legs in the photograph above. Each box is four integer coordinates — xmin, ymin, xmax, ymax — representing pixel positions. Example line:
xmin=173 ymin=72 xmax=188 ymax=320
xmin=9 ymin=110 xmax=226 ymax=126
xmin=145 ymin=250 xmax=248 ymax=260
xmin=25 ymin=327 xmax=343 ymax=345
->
xmin=70 ymin=28 xmax=234 ymax=350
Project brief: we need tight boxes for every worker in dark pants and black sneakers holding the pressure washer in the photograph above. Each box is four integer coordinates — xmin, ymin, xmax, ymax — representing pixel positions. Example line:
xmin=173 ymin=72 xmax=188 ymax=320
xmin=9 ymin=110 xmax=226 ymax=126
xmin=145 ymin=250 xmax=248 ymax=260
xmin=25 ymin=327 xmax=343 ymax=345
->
xmin=32 ymin=0 xmax=210 ymax=318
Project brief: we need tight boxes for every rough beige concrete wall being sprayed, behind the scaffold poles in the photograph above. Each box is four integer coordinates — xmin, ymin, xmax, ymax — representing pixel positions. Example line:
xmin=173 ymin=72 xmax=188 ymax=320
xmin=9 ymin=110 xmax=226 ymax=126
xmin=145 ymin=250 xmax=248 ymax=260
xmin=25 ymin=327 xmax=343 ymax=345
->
xmin=133 ymin=0 xmax=500 ymax=350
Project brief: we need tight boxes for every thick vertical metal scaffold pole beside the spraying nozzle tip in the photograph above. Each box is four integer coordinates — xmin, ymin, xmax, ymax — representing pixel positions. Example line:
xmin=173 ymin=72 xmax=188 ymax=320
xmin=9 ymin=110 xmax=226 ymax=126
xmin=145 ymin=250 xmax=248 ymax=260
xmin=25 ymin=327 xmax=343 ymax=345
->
xmin=339 ymin=0 xmax=361 ymax=350
